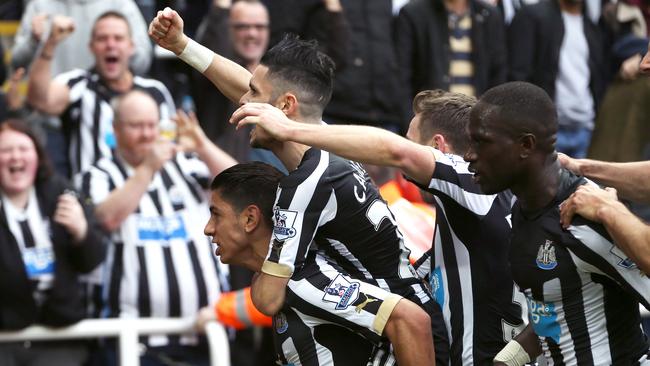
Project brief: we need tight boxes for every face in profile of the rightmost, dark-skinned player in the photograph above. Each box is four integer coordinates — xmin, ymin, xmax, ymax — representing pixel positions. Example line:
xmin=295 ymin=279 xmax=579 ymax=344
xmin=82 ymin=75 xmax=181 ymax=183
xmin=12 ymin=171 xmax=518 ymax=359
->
xmin=465 ymin=108 xmax=519 ymax=194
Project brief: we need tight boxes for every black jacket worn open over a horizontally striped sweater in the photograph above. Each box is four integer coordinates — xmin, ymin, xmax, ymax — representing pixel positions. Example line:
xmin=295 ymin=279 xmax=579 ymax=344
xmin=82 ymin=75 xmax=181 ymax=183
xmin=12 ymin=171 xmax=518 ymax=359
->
xmin=396 ymin=0 xmax=507 ymax=104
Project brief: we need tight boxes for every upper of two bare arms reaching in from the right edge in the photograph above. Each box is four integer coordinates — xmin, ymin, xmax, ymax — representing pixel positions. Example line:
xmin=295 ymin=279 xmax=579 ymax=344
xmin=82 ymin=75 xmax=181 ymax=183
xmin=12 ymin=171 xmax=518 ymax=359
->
xmin=559 ymin=154 xmax=650 ymax=203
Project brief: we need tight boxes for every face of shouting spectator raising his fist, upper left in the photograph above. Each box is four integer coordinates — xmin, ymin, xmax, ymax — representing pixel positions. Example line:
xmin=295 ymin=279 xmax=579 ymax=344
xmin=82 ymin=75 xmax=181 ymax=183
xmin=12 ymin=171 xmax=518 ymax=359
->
xmin=90 ymin=17 xmax=134 ymax=81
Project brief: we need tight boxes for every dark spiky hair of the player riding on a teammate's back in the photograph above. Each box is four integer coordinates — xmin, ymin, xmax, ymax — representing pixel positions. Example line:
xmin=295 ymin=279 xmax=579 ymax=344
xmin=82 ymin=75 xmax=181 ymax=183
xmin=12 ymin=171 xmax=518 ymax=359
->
xmin=260 ymin=35 xmax=335 ymax=118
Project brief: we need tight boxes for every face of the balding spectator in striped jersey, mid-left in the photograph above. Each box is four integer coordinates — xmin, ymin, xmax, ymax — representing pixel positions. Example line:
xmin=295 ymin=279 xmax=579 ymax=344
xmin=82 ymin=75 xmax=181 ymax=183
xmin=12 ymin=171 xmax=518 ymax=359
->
xmin=114 ymin=94 xmax=160 ymax=166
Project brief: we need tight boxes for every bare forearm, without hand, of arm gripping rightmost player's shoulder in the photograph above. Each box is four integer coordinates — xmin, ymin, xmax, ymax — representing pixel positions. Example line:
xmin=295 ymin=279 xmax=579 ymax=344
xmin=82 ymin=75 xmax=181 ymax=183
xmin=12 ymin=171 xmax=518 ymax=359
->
xmin=596 ymin=202 xmax=650 ymax=274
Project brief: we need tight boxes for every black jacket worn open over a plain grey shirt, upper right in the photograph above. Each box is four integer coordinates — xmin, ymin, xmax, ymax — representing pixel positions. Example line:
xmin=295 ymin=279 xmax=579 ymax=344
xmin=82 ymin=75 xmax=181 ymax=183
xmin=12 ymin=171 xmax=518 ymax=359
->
xmin=508 ymin=0 xmax=610 ymax=106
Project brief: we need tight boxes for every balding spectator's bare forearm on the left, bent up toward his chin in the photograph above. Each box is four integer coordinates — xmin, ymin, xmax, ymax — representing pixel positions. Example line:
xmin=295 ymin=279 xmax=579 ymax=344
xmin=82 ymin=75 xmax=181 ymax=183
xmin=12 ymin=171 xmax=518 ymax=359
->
xmin=95 ymin=165 xmax=155 ymax=231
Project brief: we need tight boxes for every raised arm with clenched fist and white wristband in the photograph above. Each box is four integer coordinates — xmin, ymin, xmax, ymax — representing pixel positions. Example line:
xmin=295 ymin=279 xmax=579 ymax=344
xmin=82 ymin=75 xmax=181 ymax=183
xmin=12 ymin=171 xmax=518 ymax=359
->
xmin=149 ymin=8 xmax=251 ymax=103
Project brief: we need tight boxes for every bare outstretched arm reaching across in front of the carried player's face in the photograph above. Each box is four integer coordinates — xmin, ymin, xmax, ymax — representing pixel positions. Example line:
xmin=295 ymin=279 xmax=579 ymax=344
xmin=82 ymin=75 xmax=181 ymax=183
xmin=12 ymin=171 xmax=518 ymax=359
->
xmin=231 ymin=103 xmax=436 ymax=185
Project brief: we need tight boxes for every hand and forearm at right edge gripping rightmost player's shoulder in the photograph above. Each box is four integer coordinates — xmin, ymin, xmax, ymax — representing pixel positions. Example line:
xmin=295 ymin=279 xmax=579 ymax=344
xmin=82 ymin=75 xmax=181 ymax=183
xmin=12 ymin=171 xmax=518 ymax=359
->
xmin=560 ymin=184 xmax=650 ymax=274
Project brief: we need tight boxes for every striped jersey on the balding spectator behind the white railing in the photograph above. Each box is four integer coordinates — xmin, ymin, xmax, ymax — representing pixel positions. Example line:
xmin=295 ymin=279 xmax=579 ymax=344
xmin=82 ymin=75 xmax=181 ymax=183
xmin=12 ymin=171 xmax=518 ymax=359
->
xmin=77 ymin=154 xmax=226 ymax=346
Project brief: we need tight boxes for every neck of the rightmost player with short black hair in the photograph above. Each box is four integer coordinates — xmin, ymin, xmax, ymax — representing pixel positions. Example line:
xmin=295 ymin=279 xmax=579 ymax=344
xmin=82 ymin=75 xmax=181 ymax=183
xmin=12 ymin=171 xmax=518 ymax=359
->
xmin=512 ymin=157 xmax=560 ymax=212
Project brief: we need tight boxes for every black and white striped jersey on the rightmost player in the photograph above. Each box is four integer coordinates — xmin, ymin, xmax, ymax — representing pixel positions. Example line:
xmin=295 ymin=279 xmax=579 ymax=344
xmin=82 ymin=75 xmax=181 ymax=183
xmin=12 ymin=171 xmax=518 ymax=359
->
xmin=510 ymin=169 xmax=650 ymax=365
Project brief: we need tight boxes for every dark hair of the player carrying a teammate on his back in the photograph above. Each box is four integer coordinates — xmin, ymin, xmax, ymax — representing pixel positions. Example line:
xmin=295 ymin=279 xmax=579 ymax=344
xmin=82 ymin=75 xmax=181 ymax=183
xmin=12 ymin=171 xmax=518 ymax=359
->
xmin=210 ymin=161 xmax=284 ymax=226
